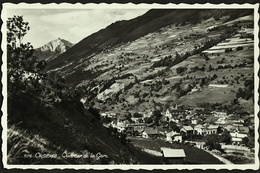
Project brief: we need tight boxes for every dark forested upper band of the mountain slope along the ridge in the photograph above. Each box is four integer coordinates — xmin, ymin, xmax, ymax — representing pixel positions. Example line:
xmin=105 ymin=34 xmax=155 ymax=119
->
xmin=47 ymin=9 xmax=252 ymax=70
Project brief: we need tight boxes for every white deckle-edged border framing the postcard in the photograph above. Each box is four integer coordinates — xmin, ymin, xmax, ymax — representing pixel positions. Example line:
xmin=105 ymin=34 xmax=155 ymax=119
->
xmin=1 ymin=3 xmax=259 ymax=170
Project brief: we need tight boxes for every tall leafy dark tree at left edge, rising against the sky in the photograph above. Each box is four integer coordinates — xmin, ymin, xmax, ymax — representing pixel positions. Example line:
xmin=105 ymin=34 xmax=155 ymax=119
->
xmin=7 ymin=16 xmax=46 ymax=99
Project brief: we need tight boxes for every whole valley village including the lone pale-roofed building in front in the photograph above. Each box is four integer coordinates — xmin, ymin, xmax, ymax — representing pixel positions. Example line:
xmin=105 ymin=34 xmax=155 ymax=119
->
xmin=100 ymin=105 xmax=254 ymax=163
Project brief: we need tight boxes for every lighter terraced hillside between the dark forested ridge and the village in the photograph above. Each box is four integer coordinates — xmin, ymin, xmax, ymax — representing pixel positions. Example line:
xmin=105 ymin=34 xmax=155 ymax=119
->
xmin=47 ymin=12 xmax=254 ymax=113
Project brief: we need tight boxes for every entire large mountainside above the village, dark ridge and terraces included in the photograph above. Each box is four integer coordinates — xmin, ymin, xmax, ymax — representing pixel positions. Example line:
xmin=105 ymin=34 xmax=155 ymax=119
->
xmin=44 ymin=10 xmax=254 ymax=113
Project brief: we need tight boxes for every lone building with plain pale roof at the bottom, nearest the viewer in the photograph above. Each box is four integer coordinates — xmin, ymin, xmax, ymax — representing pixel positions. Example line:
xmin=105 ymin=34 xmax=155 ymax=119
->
xmin=161 ymin=147 xmax=186 ymax=164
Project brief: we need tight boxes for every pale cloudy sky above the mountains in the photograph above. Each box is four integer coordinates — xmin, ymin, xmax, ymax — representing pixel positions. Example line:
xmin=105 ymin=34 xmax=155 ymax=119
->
xmin=7 ymin=9 xmax=148 ymax=48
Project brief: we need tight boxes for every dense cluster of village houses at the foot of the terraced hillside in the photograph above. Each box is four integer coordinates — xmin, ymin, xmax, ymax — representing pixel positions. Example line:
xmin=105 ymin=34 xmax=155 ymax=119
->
xmin=101 ymin=106 xmax=254 ymax=149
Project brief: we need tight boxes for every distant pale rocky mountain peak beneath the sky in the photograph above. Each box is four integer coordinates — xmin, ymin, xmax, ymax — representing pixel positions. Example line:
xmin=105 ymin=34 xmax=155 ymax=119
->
xmin=34 ymin=38 xmax=73 ymax=61
